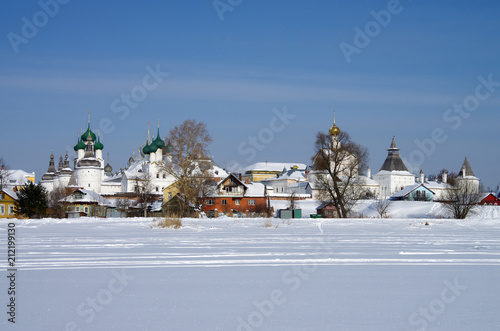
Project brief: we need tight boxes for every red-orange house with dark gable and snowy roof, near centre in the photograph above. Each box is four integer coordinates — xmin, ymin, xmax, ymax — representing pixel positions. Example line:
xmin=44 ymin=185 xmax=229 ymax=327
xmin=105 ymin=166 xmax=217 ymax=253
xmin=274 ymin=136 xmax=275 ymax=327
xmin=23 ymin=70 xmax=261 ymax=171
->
xmin=202 ymin=174 xmax=267 ymax=217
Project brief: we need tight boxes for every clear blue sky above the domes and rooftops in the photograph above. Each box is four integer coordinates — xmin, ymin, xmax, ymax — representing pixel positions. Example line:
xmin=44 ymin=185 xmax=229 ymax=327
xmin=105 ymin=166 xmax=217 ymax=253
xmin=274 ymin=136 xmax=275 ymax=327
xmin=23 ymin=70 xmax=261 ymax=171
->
xmin=0 ymin=0 xmax=500 ymax=188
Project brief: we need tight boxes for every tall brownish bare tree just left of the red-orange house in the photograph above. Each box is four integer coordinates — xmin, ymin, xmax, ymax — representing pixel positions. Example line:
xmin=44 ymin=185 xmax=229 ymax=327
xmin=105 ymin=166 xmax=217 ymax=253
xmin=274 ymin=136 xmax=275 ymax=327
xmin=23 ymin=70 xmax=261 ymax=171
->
xmin=165 ymin=119 xmax=214 ymax=216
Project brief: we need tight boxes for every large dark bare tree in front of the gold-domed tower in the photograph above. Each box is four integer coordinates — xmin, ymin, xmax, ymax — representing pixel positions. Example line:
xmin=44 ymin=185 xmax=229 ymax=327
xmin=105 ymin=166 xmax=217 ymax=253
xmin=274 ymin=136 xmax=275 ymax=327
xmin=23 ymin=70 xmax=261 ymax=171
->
xmin=313 ymin=132 xmax=368 ymax=218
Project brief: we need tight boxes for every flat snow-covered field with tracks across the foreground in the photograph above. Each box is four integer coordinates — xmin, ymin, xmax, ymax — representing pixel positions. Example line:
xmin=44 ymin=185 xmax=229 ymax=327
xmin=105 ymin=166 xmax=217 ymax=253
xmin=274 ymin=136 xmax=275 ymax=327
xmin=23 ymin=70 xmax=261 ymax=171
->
xmin=0 ymin=209 xmax=500 ymax=331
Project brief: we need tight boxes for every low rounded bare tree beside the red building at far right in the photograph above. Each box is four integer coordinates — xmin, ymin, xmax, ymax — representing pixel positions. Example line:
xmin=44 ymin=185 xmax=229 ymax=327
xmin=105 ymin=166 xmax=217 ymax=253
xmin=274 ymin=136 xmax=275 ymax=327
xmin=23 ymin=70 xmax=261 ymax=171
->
xmin=444 ymin=180 xmax=481 ymax=219
